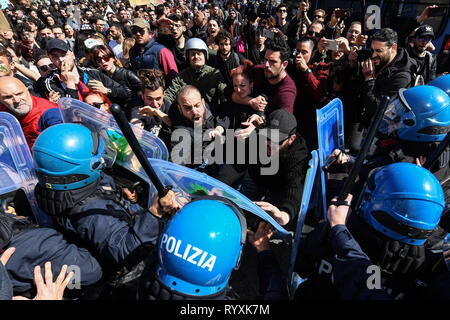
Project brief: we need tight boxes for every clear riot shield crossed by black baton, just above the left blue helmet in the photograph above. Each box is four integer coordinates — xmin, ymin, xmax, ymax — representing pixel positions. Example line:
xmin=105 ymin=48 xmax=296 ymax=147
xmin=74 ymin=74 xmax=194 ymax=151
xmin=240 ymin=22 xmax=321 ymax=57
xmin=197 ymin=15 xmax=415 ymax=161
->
xmin=58 ymin=98 xmax=169 ymax=161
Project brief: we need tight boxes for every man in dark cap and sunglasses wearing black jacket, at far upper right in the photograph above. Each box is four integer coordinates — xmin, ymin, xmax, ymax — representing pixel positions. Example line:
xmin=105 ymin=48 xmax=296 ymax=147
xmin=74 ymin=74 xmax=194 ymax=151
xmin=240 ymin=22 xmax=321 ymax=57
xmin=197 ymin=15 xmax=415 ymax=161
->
xmin=406 ymin=24 xmax=436 ymax=83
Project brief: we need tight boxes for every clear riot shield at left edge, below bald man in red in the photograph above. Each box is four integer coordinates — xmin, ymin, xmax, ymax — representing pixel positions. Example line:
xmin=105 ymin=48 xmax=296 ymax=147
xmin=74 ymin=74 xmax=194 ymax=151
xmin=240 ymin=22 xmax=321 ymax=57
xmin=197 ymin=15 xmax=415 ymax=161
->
xmin=0 ymin=112 xmax=53 ymax=227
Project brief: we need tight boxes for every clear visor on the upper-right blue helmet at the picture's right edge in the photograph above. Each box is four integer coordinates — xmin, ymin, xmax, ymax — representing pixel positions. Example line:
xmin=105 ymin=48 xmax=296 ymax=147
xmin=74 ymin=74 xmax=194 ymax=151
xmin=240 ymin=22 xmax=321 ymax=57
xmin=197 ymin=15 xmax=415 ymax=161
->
xmin=378 ymin=98 xmax=416 ymax=135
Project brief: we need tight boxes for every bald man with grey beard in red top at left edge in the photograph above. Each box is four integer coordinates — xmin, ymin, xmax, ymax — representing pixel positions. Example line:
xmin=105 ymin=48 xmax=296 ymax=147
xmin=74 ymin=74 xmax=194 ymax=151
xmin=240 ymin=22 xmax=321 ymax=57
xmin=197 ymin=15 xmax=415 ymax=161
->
xmin=0 ymin=76 xmax=62 ymax=152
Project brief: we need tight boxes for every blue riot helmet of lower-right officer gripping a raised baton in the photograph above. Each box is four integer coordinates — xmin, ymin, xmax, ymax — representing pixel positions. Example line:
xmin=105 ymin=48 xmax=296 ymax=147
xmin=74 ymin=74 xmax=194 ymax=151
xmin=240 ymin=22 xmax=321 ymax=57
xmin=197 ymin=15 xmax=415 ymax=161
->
xmin=357 ymin=162 xmax=445 ymax=246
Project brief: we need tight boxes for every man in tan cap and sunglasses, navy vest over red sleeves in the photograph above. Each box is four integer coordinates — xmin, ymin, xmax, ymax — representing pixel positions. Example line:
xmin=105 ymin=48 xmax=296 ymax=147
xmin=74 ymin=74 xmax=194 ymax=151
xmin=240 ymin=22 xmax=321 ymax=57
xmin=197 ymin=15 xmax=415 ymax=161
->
xmin=130 ymin=18 xmax=178 ymax=84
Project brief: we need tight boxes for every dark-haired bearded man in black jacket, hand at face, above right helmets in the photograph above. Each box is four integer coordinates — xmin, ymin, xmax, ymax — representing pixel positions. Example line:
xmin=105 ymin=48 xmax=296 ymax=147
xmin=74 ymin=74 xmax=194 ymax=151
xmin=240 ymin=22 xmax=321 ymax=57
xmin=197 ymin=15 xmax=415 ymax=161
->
xmin=356 ymin=28 xmax=417 ymax=127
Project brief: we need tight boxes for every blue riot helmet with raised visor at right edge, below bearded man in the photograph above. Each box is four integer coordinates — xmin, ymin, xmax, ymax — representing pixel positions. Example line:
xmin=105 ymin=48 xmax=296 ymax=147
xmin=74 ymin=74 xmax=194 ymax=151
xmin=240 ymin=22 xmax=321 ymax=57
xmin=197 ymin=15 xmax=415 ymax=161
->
xmin=379 ymin=85 xmax=450 ymax=142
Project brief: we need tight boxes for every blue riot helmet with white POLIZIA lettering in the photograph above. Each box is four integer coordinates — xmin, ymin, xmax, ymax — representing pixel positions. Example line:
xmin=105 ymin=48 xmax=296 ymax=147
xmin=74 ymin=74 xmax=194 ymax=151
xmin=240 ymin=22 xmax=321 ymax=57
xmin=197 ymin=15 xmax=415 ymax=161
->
xmin=156 ymin=196 xmax=247 ymax=298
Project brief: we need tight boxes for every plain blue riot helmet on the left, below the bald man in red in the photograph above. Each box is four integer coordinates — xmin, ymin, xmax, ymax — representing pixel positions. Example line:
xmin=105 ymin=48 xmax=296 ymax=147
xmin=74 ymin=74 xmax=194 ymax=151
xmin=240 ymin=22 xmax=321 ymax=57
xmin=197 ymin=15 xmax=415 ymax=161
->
xmin=33 ymin=123 xmax=116 ymax=190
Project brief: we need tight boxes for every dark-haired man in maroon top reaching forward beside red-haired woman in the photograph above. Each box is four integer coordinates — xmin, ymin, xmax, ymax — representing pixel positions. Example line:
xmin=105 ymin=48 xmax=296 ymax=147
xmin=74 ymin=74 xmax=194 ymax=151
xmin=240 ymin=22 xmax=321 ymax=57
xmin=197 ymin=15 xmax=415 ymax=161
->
xmin=226 ymin=38 xmax=297 ymax=115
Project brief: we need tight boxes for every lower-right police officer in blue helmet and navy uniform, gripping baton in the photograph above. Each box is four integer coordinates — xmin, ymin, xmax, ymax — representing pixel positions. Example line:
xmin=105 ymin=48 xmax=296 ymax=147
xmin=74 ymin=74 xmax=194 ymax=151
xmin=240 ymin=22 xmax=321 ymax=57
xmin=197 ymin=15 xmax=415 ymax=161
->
xmin=297 ymin=163 xmax=450 ymax=299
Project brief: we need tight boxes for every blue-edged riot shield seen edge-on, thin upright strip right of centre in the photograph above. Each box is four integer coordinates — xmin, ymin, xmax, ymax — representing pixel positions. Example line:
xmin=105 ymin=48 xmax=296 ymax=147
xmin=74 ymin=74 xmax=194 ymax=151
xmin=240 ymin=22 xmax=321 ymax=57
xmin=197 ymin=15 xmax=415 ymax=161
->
xmin=288 ymin=150 xmax=320 ymax=300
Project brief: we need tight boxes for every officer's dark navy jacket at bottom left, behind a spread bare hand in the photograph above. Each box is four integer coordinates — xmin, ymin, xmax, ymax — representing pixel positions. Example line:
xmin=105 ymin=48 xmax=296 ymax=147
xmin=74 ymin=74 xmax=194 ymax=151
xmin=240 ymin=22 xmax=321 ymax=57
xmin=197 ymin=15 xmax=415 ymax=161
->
xmin=0 ymin=212 xmax=103 ymax=298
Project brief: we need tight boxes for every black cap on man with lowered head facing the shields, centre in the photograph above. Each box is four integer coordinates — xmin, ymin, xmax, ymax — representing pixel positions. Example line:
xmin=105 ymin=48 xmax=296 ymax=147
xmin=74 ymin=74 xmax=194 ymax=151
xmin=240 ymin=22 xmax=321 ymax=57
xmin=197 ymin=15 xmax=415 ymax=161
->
xmin=266 ymin=109 xmax=297 ymax=143
